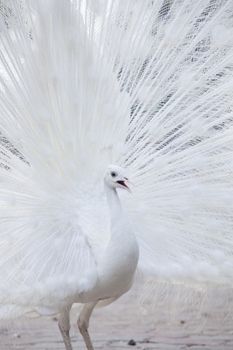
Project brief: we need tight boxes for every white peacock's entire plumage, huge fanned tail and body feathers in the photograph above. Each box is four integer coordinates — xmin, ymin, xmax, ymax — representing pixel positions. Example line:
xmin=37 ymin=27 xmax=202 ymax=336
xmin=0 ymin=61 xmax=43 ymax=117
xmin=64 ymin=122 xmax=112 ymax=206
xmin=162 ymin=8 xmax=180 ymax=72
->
xmin=0 ymin=0 xmax=233 ymax=349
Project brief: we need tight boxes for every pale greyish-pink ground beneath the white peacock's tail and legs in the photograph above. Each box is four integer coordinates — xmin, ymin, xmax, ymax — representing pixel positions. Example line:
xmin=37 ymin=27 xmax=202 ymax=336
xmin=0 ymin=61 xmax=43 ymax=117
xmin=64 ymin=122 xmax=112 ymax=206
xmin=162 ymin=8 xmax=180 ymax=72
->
xmin=0 ymin=288 xmax=233 ymax=350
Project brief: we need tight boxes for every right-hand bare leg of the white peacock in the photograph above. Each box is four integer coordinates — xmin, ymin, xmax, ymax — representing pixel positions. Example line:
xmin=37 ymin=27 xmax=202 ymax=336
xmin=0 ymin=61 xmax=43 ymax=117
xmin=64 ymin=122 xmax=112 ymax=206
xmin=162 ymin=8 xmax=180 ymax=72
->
xmin=78 ymin=302 xmax=97 ymax=350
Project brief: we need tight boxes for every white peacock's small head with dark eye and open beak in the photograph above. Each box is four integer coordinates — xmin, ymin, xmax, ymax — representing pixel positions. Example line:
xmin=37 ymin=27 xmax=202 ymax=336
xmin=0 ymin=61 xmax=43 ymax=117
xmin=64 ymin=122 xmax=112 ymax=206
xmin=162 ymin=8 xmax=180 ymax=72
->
xmin=104 ymin=165 xmax=130 ymax=192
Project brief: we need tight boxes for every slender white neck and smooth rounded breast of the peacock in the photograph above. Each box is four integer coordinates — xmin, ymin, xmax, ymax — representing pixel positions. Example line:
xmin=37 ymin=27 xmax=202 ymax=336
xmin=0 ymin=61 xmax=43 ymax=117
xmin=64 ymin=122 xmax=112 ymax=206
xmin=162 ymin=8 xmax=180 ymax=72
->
xmin=99 ymin=180 xmax=138 ymax=296
